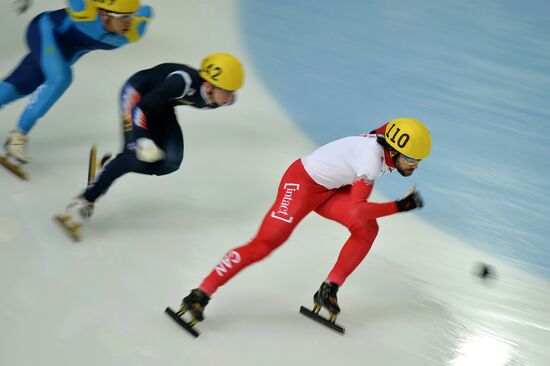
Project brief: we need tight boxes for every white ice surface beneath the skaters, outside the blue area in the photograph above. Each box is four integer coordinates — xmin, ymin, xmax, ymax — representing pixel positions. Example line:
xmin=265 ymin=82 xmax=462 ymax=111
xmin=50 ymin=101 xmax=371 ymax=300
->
xmin=0 ymin=0 xmax=550 ymax=366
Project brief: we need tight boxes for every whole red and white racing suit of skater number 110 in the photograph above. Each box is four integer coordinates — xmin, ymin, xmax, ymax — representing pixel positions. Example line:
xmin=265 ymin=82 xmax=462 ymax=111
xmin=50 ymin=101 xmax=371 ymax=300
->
xmin=199 ymin=135 xmax=398 ymax=295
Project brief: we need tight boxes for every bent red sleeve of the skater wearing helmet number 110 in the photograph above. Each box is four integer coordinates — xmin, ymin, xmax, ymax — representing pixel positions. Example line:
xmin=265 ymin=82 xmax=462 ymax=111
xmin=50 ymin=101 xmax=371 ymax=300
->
xmin=351 ymin=179 xmax=398 ymax=220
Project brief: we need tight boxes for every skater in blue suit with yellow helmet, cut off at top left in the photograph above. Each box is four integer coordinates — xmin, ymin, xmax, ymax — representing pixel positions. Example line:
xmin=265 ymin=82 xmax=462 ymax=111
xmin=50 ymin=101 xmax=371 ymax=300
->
xmin=0 ymin=0 xmax=152 ymax=163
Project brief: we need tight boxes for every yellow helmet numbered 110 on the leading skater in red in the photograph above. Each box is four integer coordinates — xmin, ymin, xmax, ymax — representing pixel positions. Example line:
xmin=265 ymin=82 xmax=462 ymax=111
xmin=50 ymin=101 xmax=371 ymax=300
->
xmin=384 ymin=118 xmax=432 ymax=160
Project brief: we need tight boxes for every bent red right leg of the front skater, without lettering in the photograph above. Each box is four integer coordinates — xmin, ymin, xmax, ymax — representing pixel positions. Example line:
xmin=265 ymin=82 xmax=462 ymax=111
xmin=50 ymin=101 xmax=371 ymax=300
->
xmin=315 ymin=186 xmax=378 ymax=286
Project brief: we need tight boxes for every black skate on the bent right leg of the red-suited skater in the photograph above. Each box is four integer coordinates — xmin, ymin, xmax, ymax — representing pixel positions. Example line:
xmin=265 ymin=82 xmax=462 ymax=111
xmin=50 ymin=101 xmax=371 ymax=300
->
xmin=300 ymin=282 xmax=345 ymax=334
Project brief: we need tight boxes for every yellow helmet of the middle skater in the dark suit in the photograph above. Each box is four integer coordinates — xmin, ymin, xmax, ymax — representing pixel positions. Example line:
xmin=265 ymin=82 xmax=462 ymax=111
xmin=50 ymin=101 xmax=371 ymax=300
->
xmin=199 ymin=53 xmax=244 ymax=91
